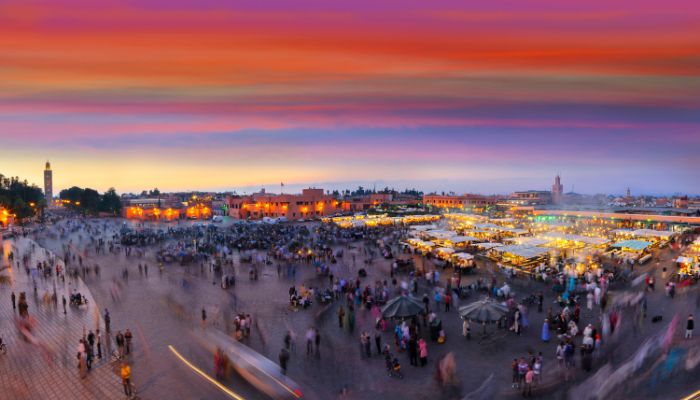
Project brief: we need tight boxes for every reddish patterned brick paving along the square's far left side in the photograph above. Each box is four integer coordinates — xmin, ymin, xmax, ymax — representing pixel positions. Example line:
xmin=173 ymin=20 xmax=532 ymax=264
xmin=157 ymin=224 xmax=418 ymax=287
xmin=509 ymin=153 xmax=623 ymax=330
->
xmin=0 ymin=239 xmax=123 ymax=400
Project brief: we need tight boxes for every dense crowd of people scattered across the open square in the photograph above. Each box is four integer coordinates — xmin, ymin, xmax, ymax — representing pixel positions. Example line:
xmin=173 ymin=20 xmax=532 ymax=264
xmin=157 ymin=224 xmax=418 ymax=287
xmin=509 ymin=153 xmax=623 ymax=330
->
xmin=2 ymin=216 xmax=694 ymax=396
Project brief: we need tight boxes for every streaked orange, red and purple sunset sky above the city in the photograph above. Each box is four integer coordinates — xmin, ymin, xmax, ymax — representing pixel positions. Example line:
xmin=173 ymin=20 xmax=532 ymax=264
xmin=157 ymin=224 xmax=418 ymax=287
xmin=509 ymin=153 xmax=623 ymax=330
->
xmin=0 ymin=0 xmax=700 ymax=194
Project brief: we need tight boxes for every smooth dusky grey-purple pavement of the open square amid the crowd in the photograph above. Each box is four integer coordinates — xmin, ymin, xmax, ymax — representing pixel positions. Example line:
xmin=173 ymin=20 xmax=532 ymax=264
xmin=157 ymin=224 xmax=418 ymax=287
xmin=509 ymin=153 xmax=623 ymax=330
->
xmin=6 ymin=219 xmax=695 ymax=399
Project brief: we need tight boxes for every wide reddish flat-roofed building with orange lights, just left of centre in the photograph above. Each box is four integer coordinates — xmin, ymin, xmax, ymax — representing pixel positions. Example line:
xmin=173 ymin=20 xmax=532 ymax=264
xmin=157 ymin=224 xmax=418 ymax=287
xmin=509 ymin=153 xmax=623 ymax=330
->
xmin=227 ymin=188 xmax=343 ymax=220
